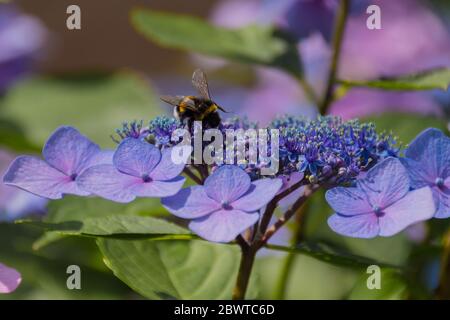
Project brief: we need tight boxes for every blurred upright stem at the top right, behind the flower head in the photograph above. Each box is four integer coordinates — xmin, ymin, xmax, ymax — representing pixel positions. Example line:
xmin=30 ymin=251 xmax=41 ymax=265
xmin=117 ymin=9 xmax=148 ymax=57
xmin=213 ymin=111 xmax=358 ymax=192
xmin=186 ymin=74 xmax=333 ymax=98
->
xmin=319 ymin=0 xmax=350 ymax=115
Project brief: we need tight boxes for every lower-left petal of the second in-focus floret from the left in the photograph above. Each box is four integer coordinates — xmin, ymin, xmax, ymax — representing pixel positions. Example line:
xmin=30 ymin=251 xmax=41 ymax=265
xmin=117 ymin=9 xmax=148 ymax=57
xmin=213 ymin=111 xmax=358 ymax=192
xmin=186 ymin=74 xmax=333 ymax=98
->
xmin=77 ymin=164 xmax=143 ymax=202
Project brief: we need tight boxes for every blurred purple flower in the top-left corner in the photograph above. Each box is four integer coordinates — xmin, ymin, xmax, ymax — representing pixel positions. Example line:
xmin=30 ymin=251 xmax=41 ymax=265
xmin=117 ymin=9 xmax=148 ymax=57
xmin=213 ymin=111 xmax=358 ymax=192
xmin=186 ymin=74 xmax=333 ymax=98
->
xmin=0 ymin=4 xmax=46 ymax=93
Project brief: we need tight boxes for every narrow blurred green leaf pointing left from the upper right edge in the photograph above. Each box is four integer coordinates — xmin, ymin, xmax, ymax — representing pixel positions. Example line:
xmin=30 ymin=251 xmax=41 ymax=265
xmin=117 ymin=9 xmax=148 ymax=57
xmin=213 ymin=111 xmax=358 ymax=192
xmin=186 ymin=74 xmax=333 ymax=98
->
xmin=339 ymin=68 xmax=450 ymax=91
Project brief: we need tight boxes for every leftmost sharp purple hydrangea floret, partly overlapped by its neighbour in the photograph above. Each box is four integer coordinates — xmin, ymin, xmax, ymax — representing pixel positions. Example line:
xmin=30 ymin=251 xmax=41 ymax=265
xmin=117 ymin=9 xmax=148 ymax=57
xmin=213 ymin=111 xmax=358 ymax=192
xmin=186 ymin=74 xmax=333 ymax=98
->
xmin=3 ymin=126 xmax=112 ymax=199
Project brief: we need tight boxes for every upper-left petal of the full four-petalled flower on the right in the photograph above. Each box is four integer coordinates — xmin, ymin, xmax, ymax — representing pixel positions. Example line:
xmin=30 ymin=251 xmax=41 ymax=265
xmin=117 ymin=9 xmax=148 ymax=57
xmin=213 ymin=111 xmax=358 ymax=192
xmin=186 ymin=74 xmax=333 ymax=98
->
xmin=325 ymin=187 xmax=373 ymax=216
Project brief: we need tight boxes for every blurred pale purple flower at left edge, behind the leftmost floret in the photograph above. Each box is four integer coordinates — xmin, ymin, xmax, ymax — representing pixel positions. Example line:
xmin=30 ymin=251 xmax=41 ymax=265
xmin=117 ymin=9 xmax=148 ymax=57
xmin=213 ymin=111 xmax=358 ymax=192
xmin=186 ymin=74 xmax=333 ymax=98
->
xmin=0 ymin=149 xmax=47 ymax=221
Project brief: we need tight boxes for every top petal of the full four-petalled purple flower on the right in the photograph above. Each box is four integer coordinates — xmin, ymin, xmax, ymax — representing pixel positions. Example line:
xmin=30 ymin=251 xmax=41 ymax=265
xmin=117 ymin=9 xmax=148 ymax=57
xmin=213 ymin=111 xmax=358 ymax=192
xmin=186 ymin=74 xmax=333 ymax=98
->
xmin=358 ymin=158 xmax=410 ymax=208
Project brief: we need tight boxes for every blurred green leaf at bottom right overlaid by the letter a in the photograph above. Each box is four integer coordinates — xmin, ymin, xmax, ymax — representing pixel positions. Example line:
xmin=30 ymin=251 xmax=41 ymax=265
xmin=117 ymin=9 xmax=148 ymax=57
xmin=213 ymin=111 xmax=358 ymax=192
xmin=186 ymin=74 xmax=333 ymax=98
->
xmin=348 ymin=268 xmax=408 ymax=300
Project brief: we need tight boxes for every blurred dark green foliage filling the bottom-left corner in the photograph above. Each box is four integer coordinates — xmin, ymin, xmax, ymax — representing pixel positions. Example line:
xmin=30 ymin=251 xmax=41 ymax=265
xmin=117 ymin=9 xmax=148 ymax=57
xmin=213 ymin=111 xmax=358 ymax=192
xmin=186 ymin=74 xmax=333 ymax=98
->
xmin=0 ymin=223 xmax=132 ymax=300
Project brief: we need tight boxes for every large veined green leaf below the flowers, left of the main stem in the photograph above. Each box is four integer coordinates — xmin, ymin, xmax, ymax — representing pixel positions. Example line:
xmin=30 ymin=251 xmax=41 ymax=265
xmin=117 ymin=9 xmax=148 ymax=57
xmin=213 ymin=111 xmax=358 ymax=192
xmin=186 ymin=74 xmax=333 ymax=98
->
xmin=97 ymin=239 xmax=254 ymax=299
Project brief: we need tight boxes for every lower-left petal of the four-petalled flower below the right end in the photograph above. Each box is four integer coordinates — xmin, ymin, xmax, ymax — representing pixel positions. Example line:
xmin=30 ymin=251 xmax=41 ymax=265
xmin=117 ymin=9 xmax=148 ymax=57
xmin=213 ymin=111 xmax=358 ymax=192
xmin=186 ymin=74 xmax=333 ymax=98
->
xmin=328 ymin=213 xmax=380 ymax=239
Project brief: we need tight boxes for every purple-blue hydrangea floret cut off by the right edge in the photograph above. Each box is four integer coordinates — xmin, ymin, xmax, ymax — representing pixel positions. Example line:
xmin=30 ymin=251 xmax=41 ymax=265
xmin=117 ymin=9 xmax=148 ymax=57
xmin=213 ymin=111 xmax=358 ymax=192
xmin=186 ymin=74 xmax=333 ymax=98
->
xmin=402 ymin=128 xmax=450 ymax=218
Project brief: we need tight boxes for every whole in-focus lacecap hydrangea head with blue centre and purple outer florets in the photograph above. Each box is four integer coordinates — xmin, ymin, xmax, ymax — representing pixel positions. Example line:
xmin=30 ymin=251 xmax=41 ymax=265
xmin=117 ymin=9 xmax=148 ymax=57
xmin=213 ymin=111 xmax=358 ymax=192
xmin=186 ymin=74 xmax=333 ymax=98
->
xmin=3 ymin=116 xmax=450 ymax=244
